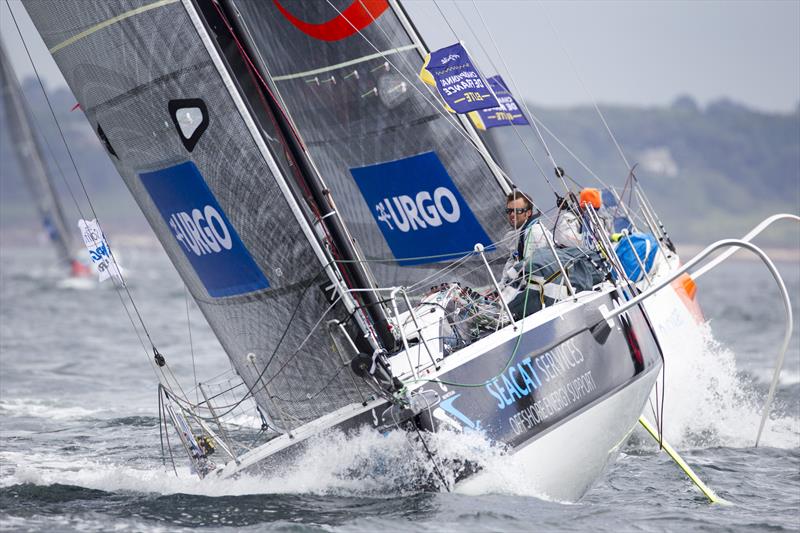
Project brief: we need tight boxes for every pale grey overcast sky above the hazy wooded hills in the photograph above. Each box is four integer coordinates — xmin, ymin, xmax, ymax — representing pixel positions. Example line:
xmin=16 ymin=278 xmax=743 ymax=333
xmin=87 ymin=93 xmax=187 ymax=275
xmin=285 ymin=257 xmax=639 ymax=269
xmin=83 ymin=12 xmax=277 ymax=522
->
xmin=0 ymin=0 xmax=800 ymax=112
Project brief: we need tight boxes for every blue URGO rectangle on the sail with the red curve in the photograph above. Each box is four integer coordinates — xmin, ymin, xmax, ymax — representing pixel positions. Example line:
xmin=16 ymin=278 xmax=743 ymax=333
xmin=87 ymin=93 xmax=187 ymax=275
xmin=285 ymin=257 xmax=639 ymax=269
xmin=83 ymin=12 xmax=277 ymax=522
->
xmin=350 ymin=152 xmax=494 ymax=265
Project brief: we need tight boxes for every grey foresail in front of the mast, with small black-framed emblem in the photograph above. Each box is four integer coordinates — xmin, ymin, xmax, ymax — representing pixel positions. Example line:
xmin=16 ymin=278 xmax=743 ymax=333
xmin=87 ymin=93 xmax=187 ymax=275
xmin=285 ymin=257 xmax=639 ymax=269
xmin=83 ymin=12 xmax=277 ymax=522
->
xmin=24 ymin=0 xmax=370 ymax=430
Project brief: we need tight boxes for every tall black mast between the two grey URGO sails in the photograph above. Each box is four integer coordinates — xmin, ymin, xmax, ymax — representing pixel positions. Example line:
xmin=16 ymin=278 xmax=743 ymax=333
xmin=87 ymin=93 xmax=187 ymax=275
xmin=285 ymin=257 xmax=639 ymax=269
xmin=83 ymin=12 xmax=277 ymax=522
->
xmin=205 ymin=0 xmax=396 ymax=352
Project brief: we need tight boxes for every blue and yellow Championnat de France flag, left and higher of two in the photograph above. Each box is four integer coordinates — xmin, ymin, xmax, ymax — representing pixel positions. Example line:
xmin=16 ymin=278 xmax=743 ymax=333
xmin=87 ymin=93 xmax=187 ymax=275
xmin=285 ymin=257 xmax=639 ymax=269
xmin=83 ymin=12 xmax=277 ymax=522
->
xmin=420 ymin=44 xmax=499 ymax=113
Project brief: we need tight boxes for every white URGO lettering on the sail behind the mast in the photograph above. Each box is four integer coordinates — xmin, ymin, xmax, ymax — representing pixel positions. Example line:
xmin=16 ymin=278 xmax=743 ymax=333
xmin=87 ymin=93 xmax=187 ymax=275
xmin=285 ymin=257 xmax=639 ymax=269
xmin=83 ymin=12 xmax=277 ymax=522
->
xmin=375 ymin=187 xmax=461 ymax=232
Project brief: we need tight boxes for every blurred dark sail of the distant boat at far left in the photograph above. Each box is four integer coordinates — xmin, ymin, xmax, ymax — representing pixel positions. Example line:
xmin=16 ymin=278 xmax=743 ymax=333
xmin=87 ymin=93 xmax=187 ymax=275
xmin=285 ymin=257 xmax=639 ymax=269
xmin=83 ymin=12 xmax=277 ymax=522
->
xmin=0 ymin=40 xmax=77 ymax=268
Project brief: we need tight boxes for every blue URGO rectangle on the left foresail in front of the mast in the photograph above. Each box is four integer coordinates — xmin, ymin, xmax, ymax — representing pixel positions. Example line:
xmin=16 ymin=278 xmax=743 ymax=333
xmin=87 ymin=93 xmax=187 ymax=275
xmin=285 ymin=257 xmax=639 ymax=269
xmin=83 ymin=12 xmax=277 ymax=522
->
xmin=139 ymin=161 xmax=269 ymax=298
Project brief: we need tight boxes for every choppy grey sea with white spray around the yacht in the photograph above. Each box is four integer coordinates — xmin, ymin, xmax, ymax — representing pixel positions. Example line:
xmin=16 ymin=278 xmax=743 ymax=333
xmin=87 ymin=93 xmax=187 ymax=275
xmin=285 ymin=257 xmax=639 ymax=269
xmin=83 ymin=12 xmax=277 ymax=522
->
xmin=0 ymin=247 xmax=800 ymax=531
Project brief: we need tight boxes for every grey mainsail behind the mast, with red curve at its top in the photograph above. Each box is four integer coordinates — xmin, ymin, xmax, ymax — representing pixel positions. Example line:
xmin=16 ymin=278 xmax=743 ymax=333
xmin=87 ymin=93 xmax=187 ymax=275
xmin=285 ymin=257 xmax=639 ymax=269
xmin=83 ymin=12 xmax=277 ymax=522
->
xmin=222 ymin=0 xmax=507 ymax=286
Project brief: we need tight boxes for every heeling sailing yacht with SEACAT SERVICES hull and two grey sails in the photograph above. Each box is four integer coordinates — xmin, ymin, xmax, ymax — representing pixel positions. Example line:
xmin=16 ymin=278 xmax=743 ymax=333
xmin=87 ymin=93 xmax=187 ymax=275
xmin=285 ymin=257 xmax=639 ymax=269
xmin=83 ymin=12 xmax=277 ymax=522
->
xmin=18 ymin=0 xmax=676 ymax=500
